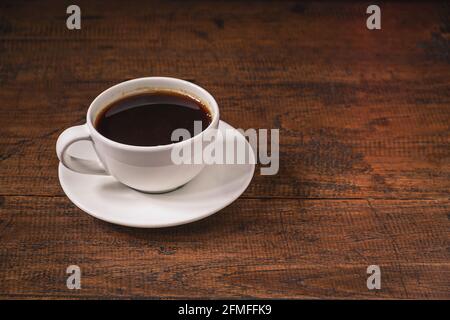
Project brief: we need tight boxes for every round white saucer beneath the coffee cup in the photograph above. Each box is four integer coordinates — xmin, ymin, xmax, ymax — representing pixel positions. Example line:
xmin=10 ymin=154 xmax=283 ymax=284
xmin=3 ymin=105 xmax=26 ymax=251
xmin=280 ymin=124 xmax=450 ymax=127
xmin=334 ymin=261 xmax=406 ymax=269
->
xmin=58 ymin=121 xmax=255 ymax=228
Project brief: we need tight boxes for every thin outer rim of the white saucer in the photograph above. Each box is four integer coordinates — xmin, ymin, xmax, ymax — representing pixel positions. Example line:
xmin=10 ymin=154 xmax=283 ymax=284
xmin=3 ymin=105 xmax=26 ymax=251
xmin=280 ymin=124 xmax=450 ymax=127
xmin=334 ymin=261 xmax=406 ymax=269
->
xmin=58 ymin=120 xmax=256 ymax=229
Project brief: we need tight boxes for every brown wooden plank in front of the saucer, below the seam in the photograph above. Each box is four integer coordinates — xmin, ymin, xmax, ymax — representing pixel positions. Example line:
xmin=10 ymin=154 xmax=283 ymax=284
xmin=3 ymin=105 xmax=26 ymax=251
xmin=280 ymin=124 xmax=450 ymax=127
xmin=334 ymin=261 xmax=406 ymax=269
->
xmin=0 ymin=196 xmax=450 ymax=299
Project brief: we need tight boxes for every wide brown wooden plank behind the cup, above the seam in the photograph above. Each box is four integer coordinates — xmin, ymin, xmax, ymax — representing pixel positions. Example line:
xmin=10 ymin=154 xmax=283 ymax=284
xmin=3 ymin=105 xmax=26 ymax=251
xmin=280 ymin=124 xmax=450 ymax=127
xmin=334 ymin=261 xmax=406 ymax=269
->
xmin=0 ymin=1 xmax=450 ymax=199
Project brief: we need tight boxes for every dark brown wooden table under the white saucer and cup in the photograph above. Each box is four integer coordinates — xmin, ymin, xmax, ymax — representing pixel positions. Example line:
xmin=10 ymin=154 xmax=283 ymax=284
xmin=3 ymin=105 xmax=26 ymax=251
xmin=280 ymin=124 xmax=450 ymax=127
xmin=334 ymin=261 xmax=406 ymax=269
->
xmin=0 ymin=0 xmax=450 ymax=299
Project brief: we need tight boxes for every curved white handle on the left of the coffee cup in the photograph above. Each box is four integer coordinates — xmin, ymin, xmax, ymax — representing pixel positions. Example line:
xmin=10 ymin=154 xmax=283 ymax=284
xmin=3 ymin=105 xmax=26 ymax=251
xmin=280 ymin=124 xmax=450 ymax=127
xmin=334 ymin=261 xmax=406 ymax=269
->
xmin=56 ymin=124 xmax=108 ymax=175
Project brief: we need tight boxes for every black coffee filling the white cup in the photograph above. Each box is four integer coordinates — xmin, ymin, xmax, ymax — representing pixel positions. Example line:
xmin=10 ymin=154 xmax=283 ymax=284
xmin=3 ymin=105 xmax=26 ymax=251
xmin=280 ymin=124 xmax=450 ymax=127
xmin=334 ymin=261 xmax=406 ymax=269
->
xmin=95 ymin=91 xmax=211 ymax=146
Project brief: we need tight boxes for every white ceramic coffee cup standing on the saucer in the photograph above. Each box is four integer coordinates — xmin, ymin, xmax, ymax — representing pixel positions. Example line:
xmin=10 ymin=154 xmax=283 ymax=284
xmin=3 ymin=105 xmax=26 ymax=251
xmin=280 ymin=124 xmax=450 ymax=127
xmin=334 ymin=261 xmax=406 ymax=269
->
xmin=56 ymin=77 xmax=219 ymax=193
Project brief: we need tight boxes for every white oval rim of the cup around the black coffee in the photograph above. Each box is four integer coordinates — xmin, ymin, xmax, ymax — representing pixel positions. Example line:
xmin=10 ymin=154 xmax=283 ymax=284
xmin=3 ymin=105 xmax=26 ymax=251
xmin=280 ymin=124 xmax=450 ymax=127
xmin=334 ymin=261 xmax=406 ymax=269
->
xmin=86 ymin=77 xmax=219 ymax=151
